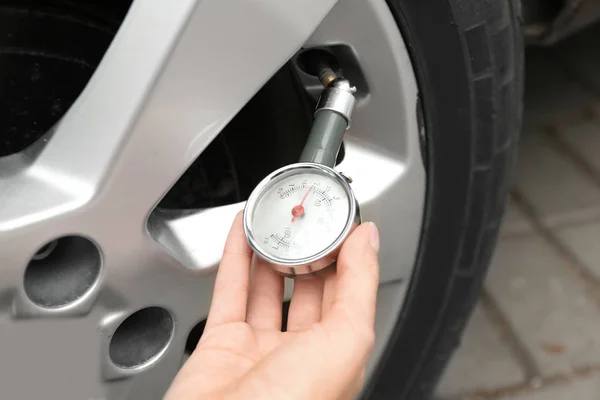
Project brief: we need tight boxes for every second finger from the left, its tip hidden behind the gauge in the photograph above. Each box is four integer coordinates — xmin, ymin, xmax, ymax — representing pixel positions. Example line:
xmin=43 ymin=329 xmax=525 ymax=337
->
xmin=246 ymin=258 xmax=283 ymax=330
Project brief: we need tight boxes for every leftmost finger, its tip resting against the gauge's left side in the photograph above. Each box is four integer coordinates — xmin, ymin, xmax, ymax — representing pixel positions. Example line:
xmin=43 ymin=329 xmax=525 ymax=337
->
xmin=206 ymin=213 xmax=252 ymax=327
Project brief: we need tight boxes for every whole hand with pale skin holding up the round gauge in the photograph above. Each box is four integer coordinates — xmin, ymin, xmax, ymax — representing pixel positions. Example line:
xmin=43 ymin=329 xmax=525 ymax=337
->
xmin=165 ymin=213 xmax=379 ymax=400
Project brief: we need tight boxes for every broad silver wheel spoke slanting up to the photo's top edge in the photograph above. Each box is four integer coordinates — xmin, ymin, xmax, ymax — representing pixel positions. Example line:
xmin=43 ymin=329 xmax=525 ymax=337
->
xmin=38 ymin=0 xmax=335 ymax=222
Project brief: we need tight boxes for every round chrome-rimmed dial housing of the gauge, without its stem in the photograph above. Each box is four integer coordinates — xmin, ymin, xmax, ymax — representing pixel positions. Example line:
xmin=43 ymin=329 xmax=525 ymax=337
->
xmin=244 ymin=163 xmax=360 ymax=277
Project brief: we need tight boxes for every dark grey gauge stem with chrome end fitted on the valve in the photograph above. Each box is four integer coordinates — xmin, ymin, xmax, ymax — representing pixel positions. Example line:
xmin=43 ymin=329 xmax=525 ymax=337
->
xmin=300 ymin=74 xmax=356 ymax=167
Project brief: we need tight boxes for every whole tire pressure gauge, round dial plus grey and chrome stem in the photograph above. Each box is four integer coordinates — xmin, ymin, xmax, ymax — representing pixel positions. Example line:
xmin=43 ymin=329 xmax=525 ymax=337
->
xmin=244 ymin=67 xmax=360 ymax=278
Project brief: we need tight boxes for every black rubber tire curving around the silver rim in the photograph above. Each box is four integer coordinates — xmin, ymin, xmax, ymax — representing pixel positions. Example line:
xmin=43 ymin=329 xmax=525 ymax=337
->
xmin=363 ymin=0 xmax=523 ymax=399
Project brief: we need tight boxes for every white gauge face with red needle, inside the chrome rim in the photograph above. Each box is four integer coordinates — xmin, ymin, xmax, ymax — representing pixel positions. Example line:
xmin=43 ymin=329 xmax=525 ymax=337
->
xmin=250 ymin=169 xmax=351 ymax=262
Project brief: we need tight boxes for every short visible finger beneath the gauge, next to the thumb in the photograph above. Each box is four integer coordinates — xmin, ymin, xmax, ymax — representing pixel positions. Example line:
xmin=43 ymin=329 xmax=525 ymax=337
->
xmin=287 ymin=278 xmax=324 ymax=332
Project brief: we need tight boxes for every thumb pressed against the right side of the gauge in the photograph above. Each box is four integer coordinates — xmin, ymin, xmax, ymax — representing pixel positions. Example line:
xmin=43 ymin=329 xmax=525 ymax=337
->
xmin=330 ymin=222 xmax=379 ymax=330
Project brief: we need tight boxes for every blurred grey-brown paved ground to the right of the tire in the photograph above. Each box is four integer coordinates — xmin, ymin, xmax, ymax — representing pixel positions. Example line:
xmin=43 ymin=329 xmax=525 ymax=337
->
xmin=436 ymin=22 xmax=600 ymax=400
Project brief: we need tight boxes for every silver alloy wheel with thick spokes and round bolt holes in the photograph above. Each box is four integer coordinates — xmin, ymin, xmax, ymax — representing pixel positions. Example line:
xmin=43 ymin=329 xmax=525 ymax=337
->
xmin=0 ymin=0 xmax=425 ymax=399
